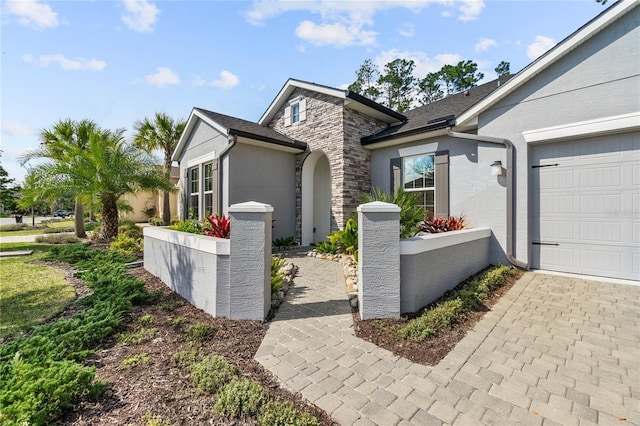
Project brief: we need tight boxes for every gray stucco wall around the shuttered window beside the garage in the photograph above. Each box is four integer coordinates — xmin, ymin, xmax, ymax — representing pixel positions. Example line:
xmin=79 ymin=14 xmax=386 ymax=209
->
xmin=371 ymin=135 xmax=507 ymax=263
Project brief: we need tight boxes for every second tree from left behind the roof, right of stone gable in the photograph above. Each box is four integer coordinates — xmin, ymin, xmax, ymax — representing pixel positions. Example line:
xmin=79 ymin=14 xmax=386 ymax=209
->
xmin=378 ymin=59 xmax=416 ymax=112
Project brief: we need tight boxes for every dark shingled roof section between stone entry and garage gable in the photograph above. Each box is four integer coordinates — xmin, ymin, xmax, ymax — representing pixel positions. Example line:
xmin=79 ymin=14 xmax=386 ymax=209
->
xmin=360 ymin=75 xmax=513 ymax=145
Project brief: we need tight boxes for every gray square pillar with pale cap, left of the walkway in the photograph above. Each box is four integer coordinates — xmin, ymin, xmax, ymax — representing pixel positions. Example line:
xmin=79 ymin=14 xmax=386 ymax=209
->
xmin=229 ymin=201 xmax=273 ymax=320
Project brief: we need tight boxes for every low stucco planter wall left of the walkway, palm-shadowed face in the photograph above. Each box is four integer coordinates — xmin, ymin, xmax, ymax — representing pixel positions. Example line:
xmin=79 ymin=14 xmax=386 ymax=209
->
xmin=144 ymin=226 xmax=230 ymax=317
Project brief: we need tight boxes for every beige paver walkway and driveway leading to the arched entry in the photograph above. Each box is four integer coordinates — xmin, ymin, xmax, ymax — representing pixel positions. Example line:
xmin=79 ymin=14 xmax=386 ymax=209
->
xmin=255 ymin=251 xmax=640 ymax=426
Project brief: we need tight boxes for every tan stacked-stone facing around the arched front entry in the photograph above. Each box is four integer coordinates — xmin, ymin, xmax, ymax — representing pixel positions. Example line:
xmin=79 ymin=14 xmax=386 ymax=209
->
xmin=269 ymin=89 xmax=386 ymax=238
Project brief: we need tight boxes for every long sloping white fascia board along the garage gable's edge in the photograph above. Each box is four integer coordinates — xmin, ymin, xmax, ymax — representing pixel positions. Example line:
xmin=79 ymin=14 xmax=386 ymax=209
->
xmin=456 ymin=0 xmax=640 ymax=126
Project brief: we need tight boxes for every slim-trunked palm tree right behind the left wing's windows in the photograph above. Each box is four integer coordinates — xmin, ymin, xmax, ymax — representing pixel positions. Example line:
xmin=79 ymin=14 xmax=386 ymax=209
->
xmin=133 ymin=112 xmax=186 ymax=225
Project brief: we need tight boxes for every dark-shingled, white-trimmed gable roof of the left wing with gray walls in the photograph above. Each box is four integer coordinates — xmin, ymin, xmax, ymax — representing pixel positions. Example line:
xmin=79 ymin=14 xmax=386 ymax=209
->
xmin=172 ymin=107 xmax=307 ymax=161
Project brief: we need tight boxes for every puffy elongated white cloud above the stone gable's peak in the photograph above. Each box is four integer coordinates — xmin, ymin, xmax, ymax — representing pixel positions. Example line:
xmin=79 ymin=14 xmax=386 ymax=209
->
xmin=296 ymin=21 xmax=377 ymax=47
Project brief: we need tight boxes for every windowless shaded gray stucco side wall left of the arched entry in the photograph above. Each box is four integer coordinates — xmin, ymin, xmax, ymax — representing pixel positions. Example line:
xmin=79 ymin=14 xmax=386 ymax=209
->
xmin=225 ymin=142 xmax=296 ymax=239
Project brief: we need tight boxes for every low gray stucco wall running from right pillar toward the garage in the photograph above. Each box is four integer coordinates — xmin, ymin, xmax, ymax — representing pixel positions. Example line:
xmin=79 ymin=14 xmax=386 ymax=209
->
xmin=400 ymin=228 xmax=491 ymax=313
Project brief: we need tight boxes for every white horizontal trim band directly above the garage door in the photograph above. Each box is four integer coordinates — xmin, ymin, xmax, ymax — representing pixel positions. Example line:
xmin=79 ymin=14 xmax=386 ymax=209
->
xmin=522 ymin=111 xmax=640 ymax=143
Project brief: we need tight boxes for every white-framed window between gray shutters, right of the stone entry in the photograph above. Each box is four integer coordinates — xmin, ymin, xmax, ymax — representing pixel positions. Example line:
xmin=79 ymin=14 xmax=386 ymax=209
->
xmin=402 ymin=154 xmax=436 ymax=216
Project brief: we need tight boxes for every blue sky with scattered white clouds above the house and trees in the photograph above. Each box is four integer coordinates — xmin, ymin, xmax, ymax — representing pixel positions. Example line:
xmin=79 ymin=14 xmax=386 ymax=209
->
xmin=0 ymin=0 xmax=613 ymax=182
